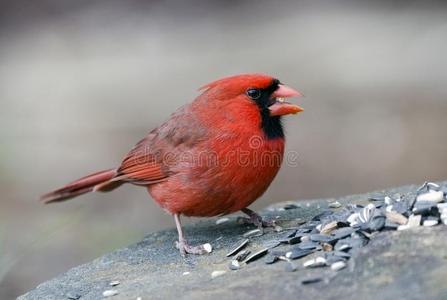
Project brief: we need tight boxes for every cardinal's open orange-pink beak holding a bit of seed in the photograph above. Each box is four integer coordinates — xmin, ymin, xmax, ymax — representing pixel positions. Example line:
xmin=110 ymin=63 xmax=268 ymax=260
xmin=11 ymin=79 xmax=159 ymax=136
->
xmin=269 ymin=84 xmax=304 ymax=116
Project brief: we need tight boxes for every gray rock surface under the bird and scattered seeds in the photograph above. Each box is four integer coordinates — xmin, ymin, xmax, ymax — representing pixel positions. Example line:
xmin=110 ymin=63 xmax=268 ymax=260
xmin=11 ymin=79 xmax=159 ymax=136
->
xmin=19 ymin=182 xmax=447 ymax=300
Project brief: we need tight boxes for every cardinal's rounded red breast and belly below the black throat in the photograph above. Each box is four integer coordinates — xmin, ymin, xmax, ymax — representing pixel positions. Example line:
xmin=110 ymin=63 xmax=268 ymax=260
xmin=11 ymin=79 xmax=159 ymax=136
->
xmin=149 ymin=131 xmax=284 ymax=216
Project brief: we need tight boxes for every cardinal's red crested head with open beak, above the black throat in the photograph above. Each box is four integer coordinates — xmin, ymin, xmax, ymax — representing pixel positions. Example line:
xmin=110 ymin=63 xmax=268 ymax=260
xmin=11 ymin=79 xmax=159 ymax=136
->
xmin=201 ymin=74 xmax=303 ymax=117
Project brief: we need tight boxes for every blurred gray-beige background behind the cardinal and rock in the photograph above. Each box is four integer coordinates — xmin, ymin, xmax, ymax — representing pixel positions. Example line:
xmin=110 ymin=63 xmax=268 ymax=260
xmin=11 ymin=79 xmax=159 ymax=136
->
xmin=0 ymin=0 xmax=447 ymax=299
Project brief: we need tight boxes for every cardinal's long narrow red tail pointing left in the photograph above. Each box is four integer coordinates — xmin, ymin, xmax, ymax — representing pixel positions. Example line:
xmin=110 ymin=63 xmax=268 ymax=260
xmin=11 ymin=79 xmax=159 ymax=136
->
xmin=40 ymin=169 xmax=122 ymax=203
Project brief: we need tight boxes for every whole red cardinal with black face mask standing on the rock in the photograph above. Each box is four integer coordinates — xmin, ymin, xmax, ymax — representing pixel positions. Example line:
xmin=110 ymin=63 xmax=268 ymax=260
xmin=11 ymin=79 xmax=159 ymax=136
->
xmin=42 ymin=74 xmax=303 ymax=255
